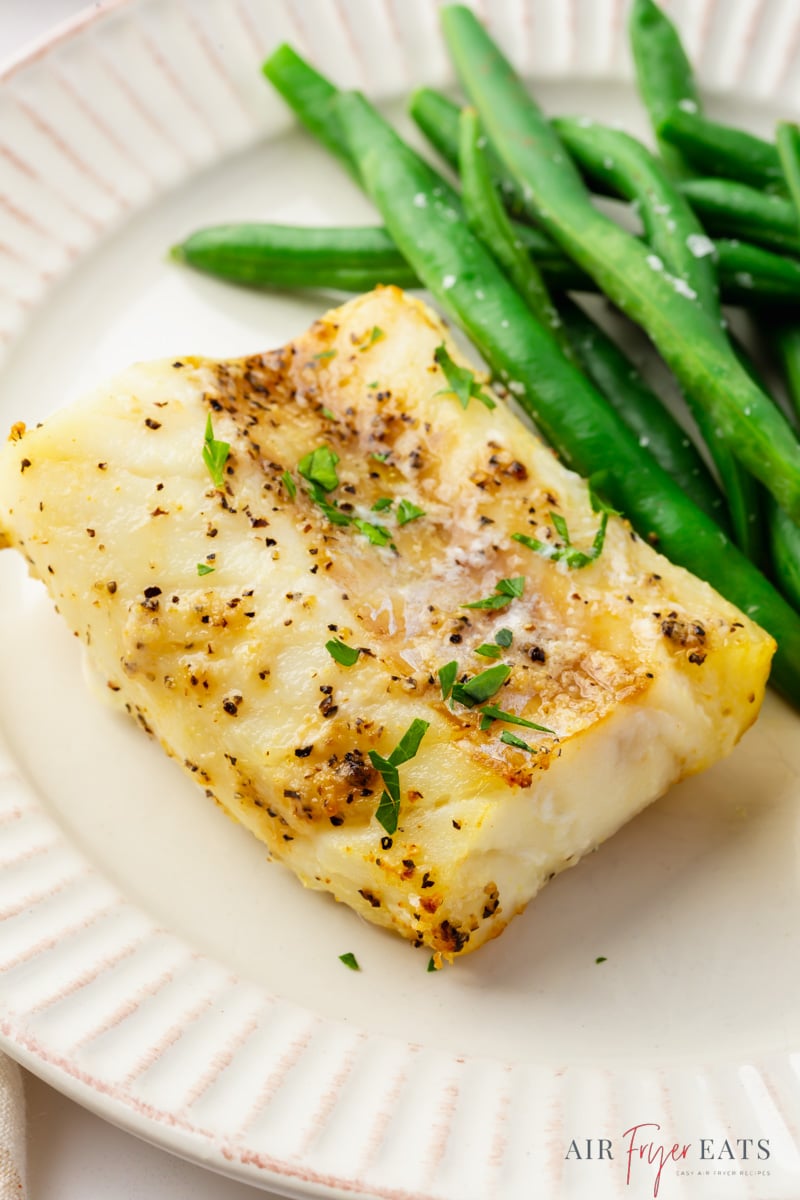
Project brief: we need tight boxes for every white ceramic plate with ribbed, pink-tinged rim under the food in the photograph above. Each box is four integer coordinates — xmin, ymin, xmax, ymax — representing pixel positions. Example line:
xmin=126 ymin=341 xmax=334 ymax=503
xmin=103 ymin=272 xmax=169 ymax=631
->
xmin=0 ymin=0 xmax=800 ymax=1200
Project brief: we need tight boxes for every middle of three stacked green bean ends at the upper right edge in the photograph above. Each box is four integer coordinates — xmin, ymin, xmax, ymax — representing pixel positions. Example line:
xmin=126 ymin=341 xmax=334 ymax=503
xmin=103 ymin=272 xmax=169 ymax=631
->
xmin=680 ymin=179 xmax=800 ymax=253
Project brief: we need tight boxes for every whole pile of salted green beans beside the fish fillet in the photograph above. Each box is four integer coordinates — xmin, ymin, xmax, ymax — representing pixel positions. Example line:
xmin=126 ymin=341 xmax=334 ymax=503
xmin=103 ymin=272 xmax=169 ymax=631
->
xmin=173 ymin=0 xmax=800 ymax=704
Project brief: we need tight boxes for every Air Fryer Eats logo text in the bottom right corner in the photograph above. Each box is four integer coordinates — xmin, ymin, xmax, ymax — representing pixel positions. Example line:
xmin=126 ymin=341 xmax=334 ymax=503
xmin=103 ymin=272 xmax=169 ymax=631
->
xmin=564 ymin=1121 xmax=770 ymax=1200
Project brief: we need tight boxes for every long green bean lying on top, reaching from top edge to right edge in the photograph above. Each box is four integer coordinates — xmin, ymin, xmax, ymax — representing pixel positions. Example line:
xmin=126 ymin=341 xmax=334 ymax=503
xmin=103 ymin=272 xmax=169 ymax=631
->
xmin=443 ymin=5 xmax=800 ymax=520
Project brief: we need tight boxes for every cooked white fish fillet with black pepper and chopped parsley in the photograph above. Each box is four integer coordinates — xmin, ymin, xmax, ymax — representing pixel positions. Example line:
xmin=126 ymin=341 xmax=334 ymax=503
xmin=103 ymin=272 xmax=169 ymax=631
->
xmin=0 ymin=288 xmax=774 ymax=956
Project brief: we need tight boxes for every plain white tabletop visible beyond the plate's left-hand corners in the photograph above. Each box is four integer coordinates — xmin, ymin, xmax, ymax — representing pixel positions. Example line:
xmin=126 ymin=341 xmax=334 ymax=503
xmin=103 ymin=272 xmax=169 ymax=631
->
xmin=0 ymin=0 xmax=287 ymax=1200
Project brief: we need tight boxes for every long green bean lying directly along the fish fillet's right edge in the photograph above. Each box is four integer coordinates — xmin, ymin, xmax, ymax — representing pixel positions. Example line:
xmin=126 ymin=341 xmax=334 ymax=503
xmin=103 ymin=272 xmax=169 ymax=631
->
xmin=337 ymin=87 xmax=800 ymax=702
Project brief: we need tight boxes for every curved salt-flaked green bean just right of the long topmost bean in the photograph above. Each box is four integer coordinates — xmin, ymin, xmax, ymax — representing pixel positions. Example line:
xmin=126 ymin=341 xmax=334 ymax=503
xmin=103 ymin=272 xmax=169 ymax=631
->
xmin=553 ymin=116 xmax=720 ymax=320
